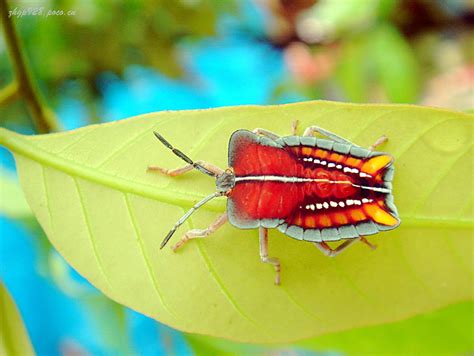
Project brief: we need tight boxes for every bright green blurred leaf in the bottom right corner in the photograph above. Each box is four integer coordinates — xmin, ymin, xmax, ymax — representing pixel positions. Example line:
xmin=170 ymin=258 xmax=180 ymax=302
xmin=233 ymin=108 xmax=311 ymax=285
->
xmin=296 ymin=301 xmax=474 ymax=355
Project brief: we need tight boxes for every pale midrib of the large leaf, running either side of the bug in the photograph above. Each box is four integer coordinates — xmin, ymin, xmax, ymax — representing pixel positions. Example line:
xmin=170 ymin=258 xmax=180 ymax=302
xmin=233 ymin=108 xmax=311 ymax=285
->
xmin=0 ymin=128 xmax=474 ymax=228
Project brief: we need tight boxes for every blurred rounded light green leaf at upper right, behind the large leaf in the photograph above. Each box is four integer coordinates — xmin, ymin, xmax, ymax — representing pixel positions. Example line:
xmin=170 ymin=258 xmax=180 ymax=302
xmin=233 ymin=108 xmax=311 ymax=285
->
xmin=336 ymin=24 xmax=420 ymax=103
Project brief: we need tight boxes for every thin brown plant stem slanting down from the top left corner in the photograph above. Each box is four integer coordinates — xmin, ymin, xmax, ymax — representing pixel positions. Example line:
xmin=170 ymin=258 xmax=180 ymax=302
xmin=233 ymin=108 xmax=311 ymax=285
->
xmin=0 ymin=0 xmax=59 ymax=133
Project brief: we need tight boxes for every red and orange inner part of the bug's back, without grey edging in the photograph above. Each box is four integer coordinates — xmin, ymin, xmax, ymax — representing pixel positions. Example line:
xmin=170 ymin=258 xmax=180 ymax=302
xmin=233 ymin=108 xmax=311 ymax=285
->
xmin=229 ymin=131 xmax=398 ymax=234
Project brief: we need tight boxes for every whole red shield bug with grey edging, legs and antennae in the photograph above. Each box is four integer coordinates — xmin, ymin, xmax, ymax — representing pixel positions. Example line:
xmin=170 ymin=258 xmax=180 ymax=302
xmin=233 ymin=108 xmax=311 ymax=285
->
xmin=148 ymin=123 xmax=400 ymax=284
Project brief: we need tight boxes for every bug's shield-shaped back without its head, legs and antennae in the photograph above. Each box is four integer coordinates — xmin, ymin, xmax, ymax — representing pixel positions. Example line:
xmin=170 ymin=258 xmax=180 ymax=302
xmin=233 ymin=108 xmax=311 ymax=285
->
xmin=228 ymin=129 xmax=399 ymax=240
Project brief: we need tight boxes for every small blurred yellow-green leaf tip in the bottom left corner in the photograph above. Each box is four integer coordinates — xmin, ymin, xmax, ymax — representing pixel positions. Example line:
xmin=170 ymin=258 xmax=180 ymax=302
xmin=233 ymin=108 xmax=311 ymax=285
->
xmin=0 ymin=282 xmax=35 ymax=356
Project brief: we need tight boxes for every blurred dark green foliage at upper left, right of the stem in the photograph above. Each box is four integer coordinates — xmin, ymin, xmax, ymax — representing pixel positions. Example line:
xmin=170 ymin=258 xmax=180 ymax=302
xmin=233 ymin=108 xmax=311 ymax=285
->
xmin=9 ymin=0 xmax=228 ymax=81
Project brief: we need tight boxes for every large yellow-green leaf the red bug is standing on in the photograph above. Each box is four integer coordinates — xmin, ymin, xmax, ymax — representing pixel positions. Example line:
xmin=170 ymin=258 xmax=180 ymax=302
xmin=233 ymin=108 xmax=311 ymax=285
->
xmin=0 ymin=102 xmax=474 ymax=343
